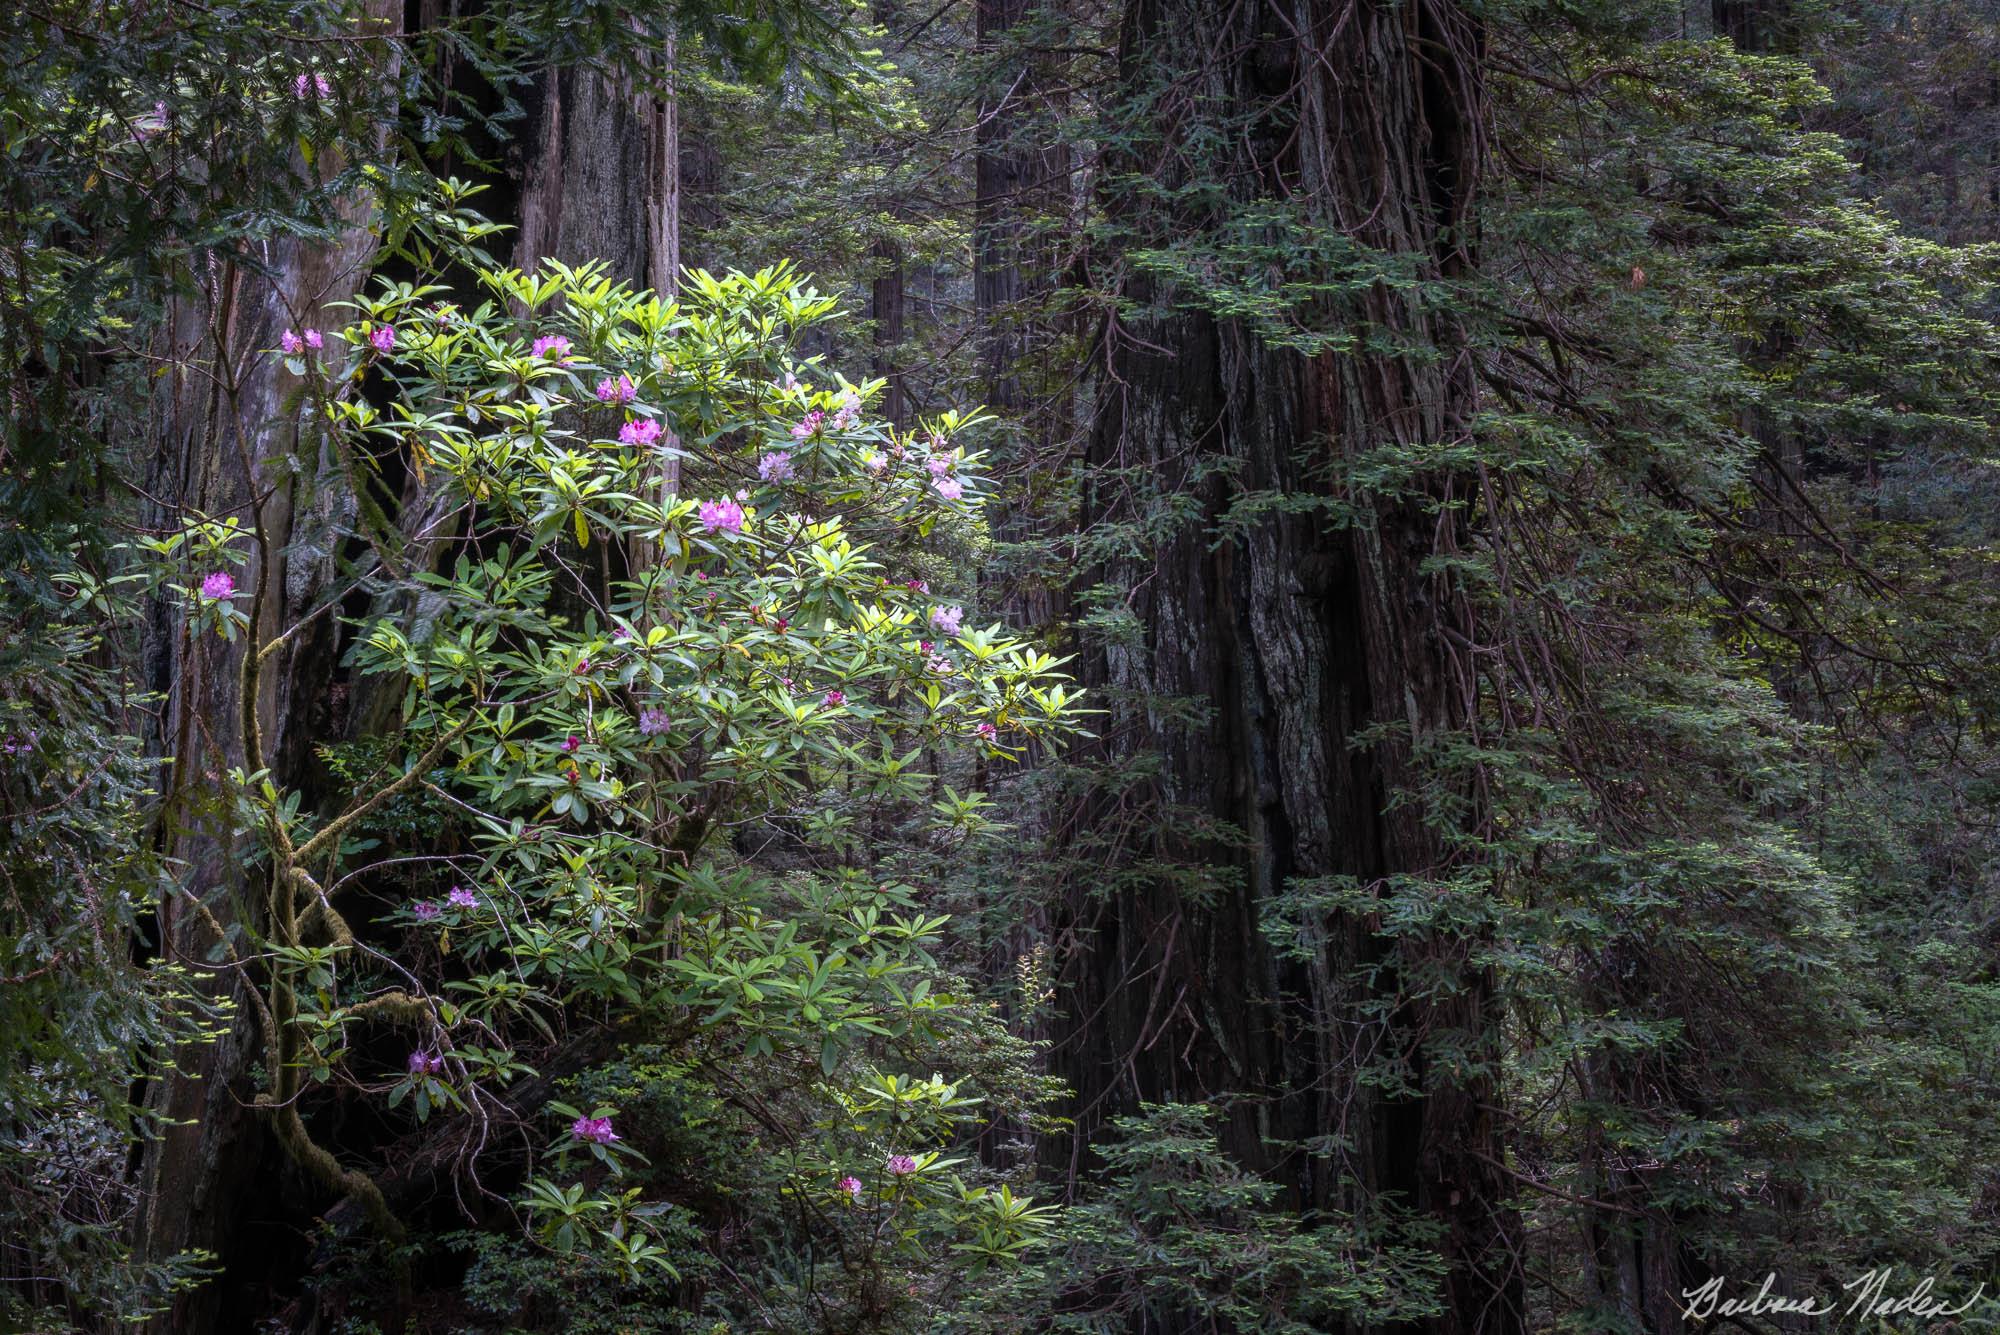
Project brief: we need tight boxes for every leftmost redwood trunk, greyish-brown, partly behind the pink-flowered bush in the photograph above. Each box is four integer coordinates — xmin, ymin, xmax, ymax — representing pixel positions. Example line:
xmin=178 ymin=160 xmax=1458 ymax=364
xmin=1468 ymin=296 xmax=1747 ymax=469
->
xmin=138 ymin=0 xmax=402 ymax=1333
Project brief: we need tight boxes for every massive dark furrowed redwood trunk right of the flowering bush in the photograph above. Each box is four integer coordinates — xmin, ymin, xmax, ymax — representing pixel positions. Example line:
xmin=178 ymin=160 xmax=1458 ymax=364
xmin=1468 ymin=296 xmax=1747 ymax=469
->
xmin=1058 ymin=0 xmax=1524 ymax=1331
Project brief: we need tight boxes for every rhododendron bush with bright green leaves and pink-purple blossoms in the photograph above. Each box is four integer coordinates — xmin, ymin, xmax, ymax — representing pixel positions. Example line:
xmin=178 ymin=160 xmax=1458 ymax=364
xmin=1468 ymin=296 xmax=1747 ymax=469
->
xmin=197 ymin=242 xmax=1076 ymax=1301
